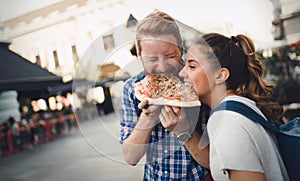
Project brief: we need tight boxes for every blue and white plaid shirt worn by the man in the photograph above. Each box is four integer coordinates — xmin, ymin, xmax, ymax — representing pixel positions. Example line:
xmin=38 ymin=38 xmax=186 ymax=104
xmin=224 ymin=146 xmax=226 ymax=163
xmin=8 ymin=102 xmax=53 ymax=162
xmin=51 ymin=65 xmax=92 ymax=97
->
xmin=120 ymin=72 xmax=205 ymax=181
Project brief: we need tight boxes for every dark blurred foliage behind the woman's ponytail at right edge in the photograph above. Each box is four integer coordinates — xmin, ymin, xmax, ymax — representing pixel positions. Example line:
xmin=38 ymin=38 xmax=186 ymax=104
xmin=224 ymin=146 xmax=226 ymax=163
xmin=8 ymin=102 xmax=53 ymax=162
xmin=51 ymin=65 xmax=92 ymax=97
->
xmin=258 ymin=44 xmax=300 ymax=105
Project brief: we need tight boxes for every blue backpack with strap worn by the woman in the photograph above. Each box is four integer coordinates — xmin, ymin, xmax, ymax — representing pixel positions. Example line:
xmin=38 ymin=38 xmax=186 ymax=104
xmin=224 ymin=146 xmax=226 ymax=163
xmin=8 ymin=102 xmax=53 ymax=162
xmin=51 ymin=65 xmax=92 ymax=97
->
xmin=213 ymin=101 xmax=300 ymax=181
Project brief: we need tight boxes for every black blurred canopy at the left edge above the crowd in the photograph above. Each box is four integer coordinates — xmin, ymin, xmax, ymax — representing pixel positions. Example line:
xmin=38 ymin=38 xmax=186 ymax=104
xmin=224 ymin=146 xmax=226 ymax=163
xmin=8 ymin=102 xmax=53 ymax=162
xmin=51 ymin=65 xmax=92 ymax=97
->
xmin=0 ymin=42 xmax=62 ymax=92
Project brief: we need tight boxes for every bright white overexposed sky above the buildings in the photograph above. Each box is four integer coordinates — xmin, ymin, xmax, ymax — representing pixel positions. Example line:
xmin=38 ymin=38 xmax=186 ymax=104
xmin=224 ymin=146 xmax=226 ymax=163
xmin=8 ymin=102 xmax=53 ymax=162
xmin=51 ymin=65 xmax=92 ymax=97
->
xmin=0 ymin=0 xmax=273 ymax=48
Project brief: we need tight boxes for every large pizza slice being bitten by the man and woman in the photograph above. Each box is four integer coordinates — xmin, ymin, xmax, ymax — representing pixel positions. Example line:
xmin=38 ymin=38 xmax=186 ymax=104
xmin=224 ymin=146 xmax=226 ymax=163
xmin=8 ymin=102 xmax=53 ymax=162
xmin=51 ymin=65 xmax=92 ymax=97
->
xmin=134 ymin=73 xmax=201 ymax=107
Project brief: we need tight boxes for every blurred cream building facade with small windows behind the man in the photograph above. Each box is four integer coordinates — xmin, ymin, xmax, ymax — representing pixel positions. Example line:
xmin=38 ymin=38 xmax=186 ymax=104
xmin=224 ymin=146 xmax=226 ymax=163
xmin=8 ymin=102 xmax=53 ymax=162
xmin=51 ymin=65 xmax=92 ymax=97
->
xmin=3 ymin=0 xmax=200 ymax=81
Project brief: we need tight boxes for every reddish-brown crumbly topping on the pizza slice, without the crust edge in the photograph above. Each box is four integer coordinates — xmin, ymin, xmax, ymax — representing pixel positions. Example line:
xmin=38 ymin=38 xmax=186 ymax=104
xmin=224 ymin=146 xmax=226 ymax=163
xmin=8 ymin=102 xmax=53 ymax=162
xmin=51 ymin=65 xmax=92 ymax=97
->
xmin=134 ymin=73 xmax=199 ymax=102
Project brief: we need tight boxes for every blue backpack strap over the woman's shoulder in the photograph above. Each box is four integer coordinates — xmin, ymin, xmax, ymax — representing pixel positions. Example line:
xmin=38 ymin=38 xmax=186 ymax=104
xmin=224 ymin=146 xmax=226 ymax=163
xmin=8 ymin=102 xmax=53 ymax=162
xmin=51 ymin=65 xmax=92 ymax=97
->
xmin=211 ymin=100 xmax=280 ymax=133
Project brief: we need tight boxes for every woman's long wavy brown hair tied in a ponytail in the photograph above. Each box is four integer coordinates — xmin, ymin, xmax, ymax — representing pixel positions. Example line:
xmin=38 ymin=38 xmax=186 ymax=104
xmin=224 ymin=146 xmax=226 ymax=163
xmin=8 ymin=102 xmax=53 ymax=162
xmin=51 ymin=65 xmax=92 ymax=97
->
xmin=196 ymin=33 xmax=283 ymax=121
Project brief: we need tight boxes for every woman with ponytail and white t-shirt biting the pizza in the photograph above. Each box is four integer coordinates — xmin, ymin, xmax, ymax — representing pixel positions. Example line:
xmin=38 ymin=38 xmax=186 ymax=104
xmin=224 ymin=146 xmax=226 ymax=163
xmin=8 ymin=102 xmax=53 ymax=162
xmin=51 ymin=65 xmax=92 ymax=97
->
xmin=177 ymin=33 xmax=289 ymax=181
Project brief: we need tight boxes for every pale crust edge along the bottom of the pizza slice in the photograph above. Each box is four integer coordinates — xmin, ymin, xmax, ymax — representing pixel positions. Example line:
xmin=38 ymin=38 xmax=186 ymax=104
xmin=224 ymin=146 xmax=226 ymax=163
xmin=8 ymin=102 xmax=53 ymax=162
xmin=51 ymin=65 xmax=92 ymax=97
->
xmin=135 ymin=92 xmax=201 ymax=107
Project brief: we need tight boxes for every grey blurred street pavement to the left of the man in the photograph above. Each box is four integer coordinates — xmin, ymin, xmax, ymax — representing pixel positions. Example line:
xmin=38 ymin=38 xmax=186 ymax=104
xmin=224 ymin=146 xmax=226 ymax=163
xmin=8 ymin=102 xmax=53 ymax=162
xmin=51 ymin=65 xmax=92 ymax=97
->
xmin=0 ymin=113 xmax=143 ymax=181
